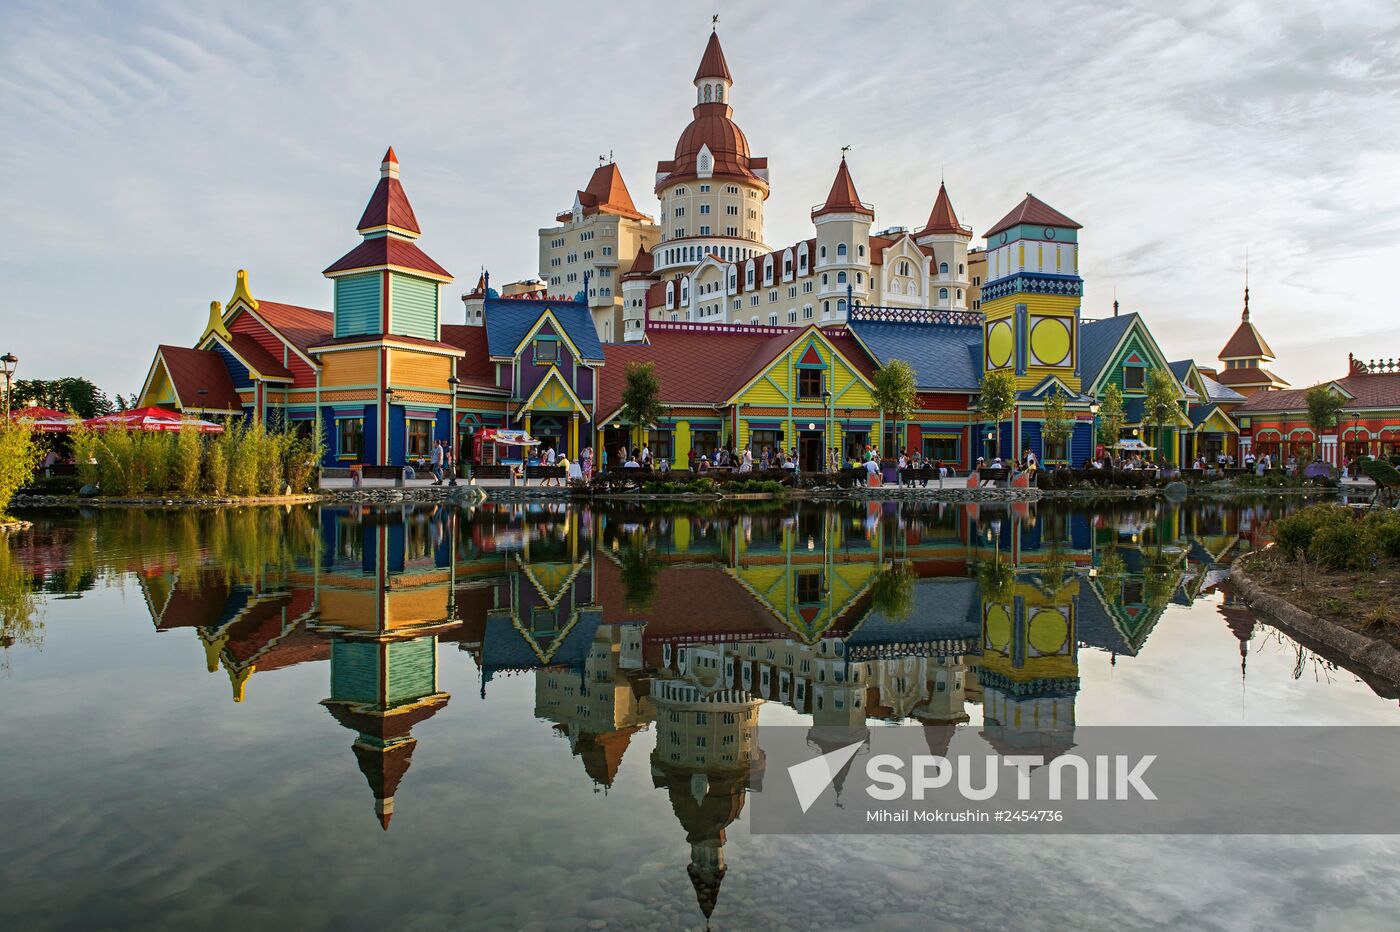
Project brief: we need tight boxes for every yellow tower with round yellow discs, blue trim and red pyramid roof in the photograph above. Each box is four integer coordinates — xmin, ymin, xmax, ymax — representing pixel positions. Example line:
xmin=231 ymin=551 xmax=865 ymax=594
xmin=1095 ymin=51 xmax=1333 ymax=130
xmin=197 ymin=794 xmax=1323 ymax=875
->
xmin=981 ymin=193 xmax=1084 ymax=392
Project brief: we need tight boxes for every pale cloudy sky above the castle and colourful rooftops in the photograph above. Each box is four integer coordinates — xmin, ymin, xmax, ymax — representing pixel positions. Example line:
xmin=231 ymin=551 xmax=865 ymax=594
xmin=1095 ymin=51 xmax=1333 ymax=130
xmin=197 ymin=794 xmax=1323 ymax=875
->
xmin=0 ymin=0 xmax=1400 ymax=393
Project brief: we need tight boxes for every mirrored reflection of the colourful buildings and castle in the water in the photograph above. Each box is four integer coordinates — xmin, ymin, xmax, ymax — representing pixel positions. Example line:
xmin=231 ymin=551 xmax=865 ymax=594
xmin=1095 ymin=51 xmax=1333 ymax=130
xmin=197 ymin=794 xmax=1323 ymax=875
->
xmin=133 ymin=502 xmax=1252 ymax=917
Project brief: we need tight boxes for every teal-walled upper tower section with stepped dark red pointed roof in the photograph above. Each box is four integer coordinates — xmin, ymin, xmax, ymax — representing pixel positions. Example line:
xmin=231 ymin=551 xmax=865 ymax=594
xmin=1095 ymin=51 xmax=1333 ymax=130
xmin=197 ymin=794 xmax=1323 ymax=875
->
xmin=323 ymin=147 xmax=452 ymax=341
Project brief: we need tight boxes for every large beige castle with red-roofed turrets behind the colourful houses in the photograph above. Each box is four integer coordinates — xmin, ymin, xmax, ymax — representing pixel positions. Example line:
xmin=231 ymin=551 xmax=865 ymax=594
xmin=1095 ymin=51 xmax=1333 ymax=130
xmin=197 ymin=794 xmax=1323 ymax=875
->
xmin=539 ymin=32 xmax=986 ymax=341
